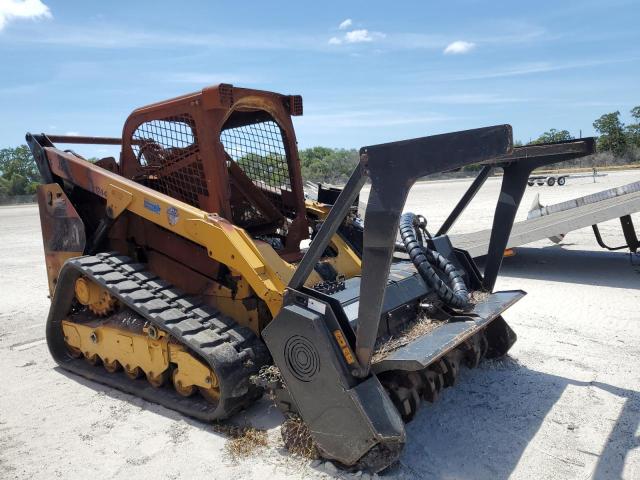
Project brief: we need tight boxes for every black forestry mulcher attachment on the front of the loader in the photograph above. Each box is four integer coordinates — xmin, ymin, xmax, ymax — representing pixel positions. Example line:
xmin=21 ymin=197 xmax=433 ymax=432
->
xmin=263 ymin=125 xmax=524 ymax=472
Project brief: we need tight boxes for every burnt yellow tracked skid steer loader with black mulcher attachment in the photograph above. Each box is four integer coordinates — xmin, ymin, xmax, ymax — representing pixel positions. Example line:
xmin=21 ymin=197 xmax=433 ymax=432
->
xmin=27 ymin=84 xmax=526 ymax=472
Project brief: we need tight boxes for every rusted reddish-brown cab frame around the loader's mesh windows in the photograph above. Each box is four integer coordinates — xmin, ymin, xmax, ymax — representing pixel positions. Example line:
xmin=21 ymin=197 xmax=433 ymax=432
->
xmin=120 ymin=84 xmax=308 ymax=251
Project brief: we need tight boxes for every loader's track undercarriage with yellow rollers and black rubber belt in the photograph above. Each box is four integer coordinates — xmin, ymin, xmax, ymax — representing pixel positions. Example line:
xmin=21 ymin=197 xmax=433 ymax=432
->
xmin=47 ymin=253 xmax=269 ymax=421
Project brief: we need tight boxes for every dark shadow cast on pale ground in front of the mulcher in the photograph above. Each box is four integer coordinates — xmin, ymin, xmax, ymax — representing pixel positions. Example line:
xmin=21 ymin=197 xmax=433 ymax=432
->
xmin=391 ymin=357 xmax=640 ymax=479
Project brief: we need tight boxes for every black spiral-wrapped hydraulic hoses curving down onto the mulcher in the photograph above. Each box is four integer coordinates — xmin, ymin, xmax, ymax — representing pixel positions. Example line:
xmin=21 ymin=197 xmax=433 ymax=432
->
xmin=400 ymin=213 xmax=470 ymax=309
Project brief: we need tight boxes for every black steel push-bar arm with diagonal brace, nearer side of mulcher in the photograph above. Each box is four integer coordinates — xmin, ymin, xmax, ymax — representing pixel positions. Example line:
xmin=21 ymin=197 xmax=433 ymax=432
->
xmin=288 ymin=125 xmax=519 ymax=377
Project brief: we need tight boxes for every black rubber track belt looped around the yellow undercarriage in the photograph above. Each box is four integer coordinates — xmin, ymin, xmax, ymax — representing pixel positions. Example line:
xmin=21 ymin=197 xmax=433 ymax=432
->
xmin=47 ymin=253 xmax=270 ymax=421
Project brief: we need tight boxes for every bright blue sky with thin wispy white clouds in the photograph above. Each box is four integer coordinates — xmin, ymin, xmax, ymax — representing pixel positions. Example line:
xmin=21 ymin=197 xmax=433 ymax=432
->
xmin=0 ymin=0 xmax=640 ymax=155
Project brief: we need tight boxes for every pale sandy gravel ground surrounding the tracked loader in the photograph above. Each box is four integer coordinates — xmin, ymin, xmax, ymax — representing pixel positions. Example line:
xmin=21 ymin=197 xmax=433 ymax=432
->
xmin=0 ymin=172 xmax=640 ymax=479
